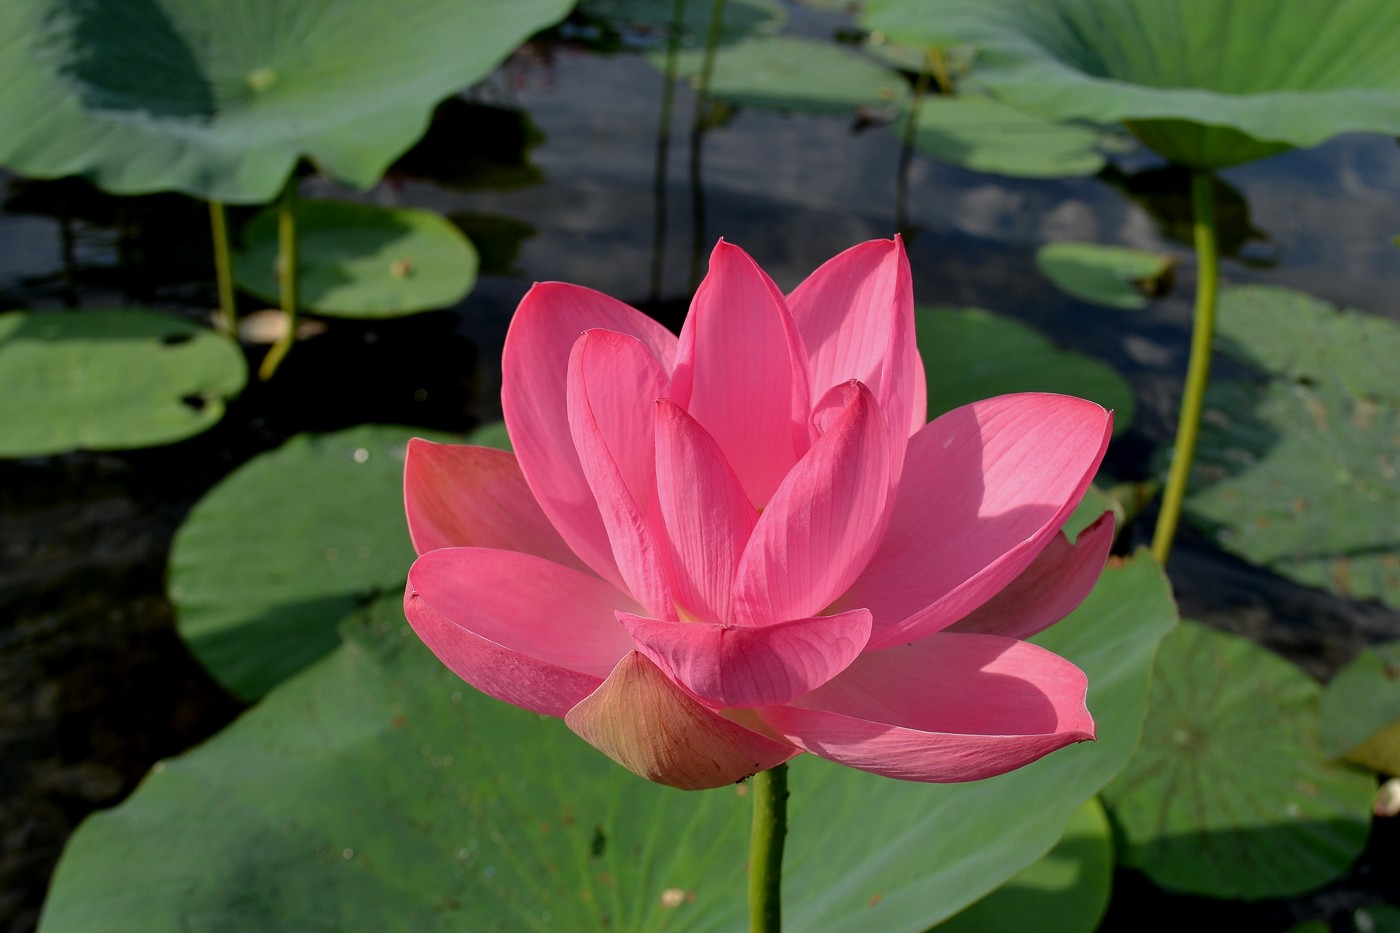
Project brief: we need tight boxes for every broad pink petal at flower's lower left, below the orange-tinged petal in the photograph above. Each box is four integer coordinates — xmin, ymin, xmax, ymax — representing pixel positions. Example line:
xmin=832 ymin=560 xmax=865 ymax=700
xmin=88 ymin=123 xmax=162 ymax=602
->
xmin=405 ymin=548 xmax=641 ymax=716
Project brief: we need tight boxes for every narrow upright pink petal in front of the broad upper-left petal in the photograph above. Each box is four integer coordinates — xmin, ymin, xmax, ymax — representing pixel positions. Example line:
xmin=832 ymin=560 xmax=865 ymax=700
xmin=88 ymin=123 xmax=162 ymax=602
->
xmin=568 ymin=331 xmax=676 ymax=619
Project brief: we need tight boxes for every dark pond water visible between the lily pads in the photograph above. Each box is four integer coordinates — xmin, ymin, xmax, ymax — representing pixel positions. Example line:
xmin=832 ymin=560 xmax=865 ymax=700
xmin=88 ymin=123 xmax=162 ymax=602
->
xmin=0 ymin=13 xmax=1400 ymax=932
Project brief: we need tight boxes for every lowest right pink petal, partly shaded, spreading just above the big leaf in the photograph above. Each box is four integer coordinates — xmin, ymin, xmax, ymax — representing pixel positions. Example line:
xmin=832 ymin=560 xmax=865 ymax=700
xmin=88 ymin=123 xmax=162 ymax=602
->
xmin=759 ymin=632 xmax=1093 ymax=783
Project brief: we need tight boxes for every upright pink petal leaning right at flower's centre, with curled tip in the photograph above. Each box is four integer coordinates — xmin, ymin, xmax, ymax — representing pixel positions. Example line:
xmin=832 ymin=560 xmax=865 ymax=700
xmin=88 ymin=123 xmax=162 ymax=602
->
xmin=734 ymin=381 xmax=889 ymax=625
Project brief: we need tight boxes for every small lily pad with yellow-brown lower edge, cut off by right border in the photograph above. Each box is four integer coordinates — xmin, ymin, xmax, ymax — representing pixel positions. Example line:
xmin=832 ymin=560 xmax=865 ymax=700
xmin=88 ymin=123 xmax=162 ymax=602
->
xmin=1322 ymin=642 xmax=1400 ymax=775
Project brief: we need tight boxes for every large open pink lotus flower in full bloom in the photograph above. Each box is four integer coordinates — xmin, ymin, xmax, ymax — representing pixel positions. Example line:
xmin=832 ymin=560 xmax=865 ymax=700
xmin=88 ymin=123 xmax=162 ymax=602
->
xmin=405 ymin=240 xmax=1113 ymax=789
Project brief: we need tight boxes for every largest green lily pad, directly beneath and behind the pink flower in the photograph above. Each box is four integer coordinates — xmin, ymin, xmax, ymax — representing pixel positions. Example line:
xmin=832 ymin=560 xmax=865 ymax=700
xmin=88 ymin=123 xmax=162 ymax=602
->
xmin=41 ymin=558 xmax=1175 ymax=933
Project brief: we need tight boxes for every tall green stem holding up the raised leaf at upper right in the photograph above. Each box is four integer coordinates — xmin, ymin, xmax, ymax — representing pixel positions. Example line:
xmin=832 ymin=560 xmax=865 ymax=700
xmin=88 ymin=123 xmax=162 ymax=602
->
xmin=1152 ymin=170 xmax=1221 ymax=565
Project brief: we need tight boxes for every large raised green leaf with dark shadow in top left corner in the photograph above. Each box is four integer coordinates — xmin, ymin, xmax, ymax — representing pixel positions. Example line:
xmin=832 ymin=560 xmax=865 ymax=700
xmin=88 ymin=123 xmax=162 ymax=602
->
xmin=0 ymin=0 xmax=573 ymax=203
